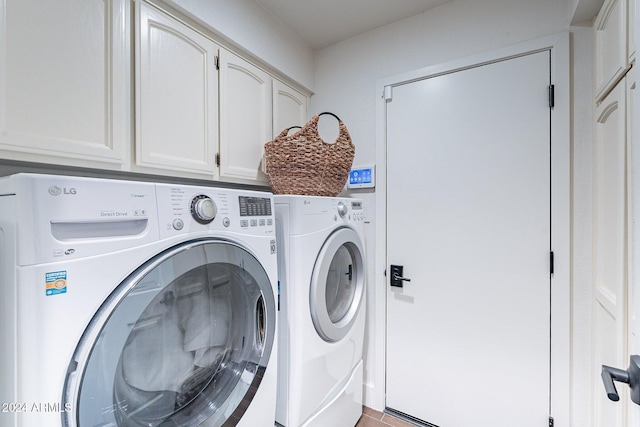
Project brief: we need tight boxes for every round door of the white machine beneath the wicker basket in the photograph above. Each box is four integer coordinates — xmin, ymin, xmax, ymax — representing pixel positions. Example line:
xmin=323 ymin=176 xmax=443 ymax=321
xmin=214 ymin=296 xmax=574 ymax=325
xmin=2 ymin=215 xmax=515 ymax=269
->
xmin=309 ymin=227 xmax=364 ymax=342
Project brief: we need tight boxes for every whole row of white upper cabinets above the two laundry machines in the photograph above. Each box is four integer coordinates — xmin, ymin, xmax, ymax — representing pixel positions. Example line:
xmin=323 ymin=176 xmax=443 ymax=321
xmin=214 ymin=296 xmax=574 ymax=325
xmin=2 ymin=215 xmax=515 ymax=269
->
xmin=0 ymin=0 xmax=309 ymax=185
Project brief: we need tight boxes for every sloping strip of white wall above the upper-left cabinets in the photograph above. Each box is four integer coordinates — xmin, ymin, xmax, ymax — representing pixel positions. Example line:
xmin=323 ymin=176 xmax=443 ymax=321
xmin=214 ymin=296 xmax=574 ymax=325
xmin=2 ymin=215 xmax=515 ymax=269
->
xmin=168 ymin=0 xmax=314 ymax=91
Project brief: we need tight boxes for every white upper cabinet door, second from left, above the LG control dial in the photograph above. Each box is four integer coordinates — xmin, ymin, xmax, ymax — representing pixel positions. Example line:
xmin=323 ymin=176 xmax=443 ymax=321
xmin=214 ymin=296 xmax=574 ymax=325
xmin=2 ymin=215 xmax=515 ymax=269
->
xmin=135 ymin=2 xmax=218 ymax=178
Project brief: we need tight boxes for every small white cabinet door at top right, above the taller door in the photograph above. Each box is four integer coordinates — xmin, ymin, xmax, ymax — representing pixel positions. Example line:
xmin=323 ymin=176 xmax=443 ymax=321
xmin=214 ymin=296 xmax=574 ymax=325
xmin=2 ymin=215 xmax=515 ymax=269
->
xmin=594 ymin=0 xmax=630 ymax=102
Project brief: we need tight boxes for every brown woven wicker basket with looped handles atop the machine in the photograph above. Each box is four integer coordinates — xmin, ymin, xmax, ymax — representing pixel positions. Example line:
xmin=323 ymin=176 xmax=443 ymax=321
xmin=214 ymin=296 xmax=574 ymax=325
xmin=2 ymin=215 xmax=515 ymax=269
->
xmin=264 ymin=113 xmax=355 ymax=197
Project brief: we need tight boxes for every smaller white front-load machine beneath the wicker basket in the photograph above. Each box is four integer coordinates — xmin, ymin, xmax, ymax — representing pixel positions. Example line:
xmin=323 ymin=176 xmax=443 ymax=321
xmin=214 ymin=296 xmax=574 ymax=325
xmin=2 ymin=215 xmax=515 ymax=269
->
xmin=274 ymin=196 xmax=366 ymax=427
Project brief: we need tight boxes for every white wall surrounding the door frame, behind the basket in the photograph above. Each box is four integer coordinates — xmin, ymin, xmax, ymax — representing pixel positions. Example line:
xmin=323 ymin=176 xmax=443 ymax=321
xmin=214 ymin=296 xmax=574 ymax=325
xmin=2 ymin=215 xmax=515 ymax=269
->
xmin=311 ymin=0 xmax=591 ymax=427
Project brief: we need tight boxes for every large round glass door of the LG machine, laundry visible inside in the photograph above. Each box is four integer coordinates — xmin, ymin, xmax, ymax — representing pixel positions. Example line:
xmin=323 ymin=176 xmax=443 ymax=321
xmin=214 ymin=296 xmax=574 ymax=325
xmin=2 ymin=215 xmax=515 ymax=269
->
xmin=63 ymin=239 xmax=276 ymax=427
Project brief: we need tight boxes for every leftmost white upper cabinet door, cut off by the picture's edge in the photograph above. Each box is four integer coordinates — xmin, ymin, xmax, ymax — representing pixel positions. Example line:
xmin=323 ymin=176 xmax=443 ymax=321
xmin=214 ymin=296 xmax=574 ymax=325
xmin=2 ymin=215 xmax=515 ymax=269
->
xmin=0 ymin=0 xmax=131 ymax=169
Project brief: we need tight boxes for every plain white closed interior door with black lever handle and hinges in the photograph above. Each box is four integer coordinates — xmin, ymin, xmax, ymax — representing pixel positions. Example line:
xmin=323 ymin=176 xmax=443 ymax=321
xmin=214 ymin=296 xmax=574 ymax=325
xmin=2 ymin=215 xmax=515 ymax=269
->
xmin=386 ymin=51 xmax=551 ymax=427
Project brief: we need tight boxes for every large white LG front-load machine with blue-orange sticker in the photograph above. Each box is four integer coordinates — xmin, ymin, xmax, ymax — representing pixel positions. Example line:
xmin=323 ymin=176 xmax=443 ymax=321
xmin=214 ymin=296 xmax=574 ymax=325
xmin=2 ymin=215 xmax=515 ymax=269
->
xmin=0 ymin=174 xmax=277 ymax=427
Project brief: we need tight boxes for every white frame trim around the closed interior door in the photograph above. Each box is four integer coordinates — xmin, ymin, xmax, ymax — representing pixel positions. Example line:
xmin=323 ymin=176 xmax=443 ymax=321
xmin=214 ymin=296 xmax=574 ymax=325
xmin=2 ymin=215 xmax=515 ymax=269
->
xmin=372 ymin=32 xmax=571 ymax=426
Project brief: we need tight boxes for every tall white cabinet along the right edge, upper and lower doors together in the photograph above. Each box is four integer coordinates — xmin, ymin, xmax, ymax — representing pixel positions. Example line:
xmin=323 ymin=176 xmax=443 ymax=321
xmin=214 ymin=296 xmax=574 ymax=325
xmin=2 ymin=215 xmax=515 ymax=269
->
xmin=590 ymin=0 xmax=639 ymax=427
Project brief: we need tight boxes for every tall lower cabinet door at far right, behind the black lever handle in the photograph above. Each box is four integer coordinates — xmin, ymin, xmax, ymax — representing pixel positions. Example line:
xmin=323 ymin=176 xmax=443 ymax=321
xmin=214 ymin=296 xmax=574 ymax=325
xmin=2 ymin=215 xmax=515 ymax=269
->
xmin=591 ymin=81 xmax=629 ymax=426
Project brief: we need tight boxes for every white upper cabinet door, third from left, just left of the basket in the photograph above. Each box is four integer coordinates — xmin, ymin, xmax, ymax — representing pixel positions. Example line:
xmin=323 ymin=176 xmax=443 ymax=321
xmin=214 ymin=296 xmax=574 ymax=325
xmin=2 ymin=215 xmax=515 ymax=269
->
xmin=220 ymin=50 xmax=272 ymax=184
